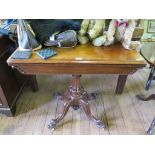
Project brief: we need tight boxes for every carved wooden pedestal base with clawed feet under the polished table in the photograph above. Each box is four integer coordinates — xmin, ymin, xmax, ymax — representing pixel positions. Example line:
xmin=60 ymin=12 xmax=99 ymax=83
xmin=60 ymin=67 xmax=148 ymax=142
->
xmin=48 ymin=75 xmax=105 ymax=129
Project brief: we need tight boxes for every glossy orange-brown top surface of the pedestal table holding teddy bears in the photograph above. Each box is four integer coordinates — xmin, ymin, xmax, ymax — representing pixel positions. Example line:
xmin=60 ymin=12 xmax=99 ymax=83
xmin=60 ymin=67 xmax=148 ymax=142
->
xmin=7 ymin=44 xmax=145 ymax=65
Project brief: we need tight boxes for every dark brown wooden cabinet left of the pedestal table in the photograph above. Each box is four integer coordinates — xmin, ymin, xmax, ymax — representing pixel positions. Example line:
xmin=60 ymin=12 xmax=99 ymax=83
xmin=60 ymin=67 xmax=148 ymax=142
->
xmin=0 ymin=36 xmax=37 ymax=116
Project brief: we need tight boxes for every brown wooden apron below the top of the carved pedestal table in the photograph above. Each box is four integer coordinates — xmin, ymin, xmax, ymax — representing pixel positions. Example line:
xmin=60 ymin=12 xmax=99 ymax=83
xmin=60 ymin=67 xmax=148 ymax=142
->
xmin=9 ymin=63 xmax=145 ymax=75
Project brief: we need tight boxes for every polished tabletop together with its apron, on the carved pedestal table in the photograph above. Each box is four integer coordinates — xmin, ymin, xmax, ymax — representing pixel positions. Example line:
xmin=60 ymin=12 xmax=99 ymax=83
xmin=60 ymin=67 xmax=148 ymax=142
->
xmin=7 ymin=44 xmax=145 ymax=93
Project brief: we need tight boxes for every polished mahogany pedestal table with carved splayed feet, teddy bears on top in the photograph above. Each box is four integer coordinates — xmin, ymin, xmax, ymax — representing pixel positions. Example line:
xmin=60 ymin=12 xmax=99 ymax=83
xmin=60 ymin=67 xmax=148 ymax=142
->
xmin=7 ymin=44 xmax=146 ymax=129
